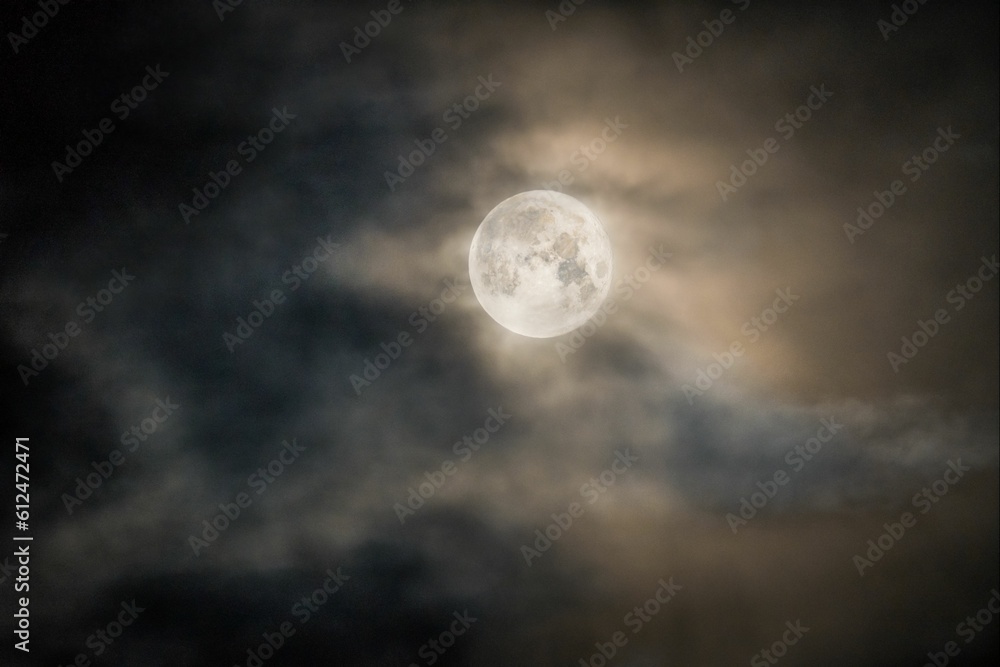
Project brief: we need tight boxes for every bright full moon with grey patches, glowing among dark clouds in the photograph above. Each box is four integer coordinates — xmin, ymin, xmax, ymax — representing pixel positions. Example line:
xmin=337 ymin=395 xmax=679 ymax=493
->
xmin=469 ymin=190 xmax=611 ymax=338
